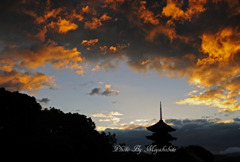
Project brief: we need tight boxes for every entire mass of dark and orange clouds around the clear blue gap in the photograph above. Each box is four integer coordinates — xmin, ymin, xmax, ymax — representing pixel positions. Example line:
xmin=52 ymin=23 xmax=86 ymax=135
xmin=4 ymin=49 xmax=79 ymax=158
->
xmin=0 ymin=0 xmax=240 ymax=111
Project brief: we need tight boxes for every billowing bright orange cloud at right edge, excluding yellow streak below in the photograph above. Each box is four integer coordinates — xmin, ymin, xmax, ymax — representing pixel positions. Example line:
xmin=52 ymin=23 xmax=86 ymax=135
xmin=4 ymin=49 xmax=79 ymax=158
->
xmin=190 ymin=28 xmax=240 ymax=86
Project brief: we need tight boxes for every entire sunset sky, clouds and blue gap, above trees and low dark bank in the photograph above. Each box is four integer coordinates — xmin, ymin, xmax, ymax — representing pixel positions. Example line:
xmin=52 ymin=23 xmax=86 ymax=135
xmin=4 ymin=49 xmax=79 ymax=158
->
xmin=0 ymin=0 xmax=240 ymax=130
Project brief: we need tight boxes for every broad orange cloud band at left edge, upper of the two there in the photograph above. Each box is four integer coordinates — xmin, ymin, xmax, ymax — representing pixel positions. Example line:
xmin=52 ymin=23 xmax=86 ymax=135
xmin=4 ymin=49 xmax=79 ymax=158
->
xmin=0 ymin=41 xmax=84 ymax=73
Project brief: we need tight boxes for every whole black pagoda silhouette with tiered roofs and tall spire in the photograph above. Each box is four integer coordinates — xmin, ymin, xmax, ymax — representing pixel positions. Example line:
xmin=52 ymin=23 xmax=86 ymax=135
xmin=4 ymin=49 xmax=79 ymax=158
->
xmin=146 ymin=102 xmax=177 ymax=148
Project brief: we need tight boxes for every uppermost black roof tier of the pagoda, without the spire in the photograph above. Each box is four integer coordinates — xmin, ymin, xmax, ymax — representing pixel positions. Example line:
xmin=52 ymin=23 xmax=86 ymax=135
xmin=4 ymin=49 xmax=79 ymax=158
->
xmin=147 ymin=120 xmax=176 ymax=132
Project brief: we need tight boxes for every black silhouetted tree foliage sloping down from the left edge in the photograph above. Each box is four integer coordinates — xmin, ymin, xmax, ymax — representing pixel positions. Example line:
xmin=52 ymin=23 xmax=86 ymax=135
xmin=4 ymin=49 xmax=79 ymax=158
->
xmin=0 ymin=88 xmax=116 ymax=161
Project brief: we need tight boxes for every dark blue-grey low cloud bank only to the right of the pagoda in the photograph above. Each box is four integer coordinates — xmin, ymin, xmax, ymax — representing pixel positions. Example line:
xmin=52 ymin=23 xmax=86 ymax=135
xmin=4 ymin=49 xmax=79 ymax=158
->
xmin=170 ymin=118 xmax=240 ymax=153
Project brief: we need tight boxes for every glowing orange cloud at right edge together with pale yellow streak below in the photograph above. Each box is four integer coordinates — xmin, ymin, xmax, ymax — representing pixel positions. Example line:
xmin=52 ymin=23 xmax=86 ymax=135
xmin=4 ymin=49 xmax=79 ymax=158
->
xmin=177 ymin=27 xmax=240 ymax=111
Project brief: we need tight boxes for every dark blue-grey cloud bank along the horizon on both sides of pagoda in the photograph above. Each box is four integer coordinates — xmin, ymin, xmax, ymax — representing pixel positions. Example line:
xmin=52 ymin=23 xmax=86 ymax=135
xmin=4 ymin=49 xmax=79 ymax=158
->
xmin=105 ymin=119 xmax=240 ymax=153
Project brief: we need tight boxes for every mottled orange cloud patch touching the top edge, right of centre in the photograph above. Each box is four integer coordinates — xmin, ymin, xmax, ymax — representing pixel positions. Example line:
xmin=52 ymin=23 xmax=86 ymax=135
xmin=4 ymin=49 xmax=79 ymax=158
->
xmin=129 ymin=0 xmax=194 ymax=42
